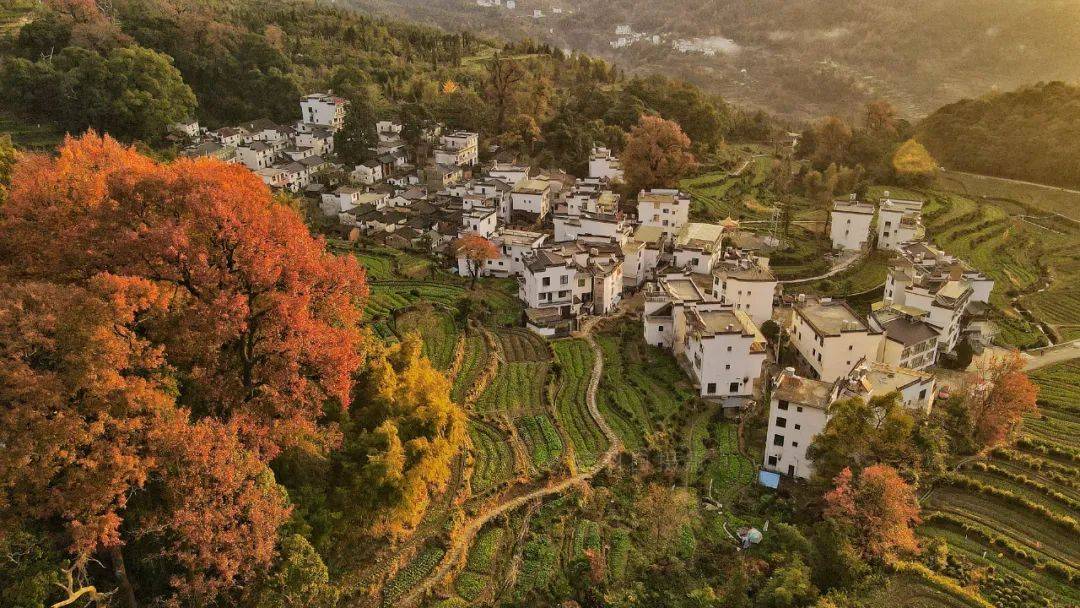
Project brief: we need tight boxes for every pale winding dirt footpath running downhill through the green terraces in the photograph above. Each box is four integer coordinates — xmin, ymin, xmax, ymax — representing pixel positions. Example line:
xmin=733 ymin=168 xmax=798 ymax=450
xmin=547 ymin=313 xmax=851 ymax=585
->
xmin=396 ymin=310 xmax=627 ymax=607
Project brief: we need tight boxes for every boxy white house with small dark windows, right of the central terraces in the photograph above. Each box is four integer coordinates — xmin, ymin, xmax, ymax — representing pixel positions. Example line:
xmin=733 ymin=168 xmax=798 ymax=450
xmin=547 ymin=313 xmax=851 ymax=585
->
xmin=683 ymin=302 xmax=767 ymax=397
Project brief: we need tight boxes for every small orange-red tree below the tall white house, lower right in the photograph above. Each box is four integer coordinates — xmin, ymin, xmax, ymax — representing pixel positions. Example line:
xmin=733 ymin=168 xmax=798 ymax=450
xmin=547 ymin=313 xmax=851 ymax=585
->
xmin=825 ymin=464 xmax=920 ymax=557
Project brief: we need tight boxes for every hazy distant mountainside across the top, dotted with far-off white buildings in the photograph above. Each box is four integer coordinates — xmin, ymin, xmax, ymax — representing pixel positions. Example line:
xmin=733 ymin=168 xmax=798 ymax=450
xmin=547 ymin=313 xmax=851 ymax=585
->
xmin=348 ymin=0 xmax=1080 ymax=119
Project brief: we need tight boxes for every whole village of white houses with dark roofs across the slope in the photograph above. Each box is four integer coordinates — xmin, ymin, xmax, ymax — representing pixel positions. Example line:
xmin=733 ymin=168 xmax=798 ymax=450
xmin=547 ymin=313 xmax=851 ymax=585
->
xmin=164 ymin=93 xmax=994 ymax=485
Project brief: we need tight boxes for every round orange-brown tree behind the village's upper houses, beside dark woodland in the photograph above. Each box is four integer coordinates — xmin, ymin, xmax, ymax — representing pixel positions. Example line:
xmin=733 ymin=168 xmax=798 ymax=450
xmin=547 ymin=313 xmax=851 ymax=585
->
xmin=622 ymin=116 xmax=698 ymax=190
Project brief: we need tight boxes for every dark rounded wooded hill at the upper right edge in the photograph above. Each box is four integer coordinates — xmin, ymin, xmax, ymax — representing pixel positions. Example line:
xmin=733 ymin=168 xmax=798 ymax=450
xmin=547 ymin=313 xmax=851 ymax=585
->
xmin=917 ymin=82 xmax=1080 ymax=188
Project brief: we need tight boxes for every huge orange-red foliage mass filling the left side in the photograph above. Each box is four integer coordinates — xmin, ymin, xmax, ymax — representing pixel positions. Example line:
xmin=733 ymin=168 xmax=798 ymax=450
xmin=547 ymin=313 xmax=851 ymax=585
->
xmin=0 ymin=133 xmax=367 ymax=605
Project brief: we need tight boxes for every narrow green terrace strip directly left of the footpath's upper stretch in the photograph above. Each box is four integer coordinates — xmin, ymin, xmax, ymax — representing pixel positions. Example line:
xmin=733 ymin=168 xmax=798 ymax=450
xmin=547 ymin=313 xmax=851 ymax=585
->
xmin=552 ymin=339 xmax=608 ymax=468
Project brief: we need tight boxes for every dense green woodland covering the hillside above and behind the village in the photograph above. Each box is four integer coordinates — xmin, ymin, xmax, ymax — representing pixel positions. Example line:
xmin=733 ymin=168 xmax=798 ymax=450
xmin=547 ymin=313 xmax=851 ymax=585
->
xmin=0 ymin=0 xmax=770 ymax=172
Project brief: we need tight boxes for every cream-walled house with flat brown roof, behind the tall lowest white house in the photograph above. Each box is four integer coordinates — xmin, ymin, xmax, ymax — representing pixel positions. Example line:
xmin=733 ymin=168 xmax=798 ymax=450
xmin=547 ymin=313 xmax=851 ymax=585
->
xmin=788 ymin=298 xmax=881 ymax=382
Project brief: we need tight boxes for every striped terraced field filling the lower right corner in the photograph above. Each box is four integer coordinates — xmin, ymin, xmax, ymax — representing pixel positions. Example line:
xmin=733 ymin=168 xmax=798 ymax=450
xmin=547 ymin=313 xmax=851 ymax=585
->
xmin=919 ymin=362 xmax=1080 ymax=608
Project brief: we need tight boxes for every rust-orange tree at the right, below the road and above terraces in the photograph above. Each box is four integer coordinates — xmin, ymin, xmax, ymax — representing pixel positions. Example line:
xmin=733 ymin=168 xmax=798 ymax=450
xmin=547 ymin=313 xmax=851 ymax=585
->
xmin=961 ymin=351 xmax=1039 ymax=447
